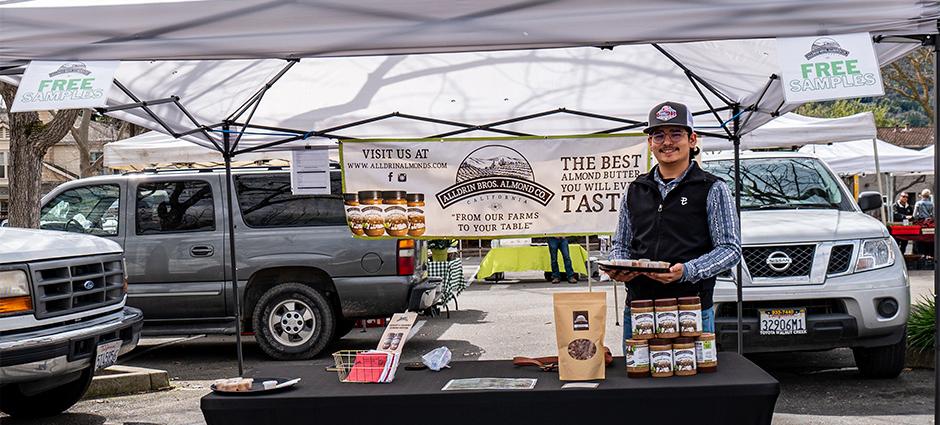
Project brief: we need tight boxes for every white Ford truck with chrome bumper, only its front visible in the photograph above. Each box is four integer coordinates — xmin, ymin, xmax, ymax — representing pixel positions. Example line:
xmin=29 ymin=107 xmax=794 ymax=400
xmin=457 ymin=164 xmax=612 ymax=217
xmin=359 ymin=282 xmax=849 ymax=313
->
xmin=0 ymin=227 xmax=143 ymax=417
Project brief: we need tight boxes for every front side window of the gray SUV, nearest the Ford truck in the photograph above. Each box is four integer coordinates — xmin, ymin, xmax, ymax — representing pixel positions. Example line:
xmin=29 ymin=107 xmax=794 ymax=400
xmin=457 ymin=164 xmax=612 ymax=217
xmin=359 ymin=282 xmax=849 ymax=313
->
xmin=39 ymin=184 xmax=121 ymax=236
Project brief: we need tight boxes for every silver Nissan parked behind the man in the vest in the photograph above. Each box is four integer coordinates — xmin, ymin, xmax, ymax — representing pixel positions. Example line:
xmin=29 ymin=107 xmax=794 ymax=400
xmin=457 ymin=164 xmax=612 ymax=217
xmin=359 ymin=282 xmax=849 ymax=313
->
xmin=702 ymin=153 xmax=910 ymax=377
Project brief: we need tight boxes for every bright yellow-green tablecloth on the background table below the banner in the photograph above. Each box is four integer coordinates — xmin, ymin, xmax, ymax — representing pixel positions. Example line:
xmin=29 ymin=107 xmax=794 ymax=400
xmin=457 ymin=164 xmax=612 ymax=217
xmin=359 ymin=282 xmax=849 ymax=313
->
xmin=477 ymin=244 xmax=588 ymax=279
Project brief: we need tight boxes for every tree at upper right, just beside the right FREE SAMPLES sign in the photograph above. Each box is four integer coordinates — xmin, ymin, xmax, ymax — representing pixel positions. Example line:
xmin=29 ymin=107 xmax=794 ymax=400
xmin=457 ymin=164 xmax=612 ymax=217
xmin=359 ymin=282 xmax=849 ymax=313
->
xmin=882 ymin=47 xmax=933 ymax=123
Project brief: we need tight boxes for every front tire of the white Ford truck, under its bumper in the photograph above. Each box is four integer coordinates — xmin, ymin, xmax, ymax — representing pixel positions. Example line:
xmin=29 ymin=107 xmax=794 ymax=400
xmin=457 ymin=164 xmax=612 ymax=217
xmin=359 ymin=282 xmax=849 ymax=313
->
xmin=0 ymin=366 xmax=95 ymax=418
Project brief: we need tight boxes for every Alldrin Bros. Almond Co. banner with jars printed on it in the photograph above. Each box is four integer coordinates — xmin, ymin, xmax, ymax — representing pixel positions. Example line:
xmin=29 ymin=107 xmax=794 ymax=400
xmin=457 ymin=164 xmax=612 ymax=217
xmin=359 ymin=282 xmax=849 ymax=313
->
xmin=340 ymin=134 xmax=649 ymax=239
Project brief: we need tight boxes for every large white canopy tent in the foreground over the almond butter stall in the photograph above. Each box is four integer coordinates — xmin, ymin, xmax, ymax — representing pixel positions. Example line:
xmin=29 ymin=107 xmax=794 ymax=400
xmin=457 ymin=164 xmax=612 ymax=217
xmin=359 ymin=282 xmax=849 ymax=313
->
xmin=0 ymin=0 xmax=940 ymax=380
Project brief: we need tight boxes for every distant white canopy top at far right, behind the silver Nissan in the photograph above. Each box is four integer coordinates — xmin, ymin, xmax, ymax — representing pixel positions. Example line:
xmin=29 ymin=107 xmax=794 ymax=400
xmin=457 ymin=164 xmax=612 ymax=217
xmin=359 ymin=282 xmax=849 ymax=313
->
xmin=800 ymin=139 xmax=933 ymax=174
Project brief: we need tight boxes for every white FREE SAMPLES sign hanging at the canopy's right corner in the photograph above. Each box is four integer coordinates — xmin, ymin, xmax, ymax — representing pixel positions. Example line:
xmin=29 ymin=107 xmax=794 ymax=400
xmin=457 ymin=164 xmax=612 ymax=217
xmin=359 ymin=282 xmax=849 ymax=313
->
xmin=777 ymin=33 xmax=884 ymax=103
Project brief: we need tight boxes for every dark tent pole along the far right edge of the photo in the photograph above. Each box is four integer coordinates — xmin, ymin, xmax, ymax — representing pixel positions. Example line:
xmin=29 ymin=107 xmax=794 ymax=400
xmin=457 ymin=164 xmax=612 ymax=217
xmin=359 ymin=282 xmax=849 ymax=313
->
xmin=928 ymin=24 xmax=940 ymax=423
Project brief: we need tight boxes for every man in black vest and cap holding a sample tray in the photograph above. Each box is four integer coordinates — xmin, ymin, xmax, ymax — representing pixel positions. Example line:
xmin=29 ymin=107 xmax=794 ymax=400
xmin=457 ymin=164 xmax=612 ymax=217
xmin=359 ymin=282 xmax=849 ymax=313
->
xmin=607 ymin=102 xmax=741 ymax=339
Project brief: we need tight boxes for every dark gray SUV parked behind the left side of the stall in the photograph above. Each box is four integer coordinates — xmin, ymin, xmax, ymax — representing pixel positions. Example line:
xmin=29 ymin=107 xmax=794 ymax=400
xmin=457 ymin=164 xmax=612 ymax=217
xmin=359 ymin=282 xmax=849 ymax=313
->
xmin=40 ymin=167 xmax=440 ymax=360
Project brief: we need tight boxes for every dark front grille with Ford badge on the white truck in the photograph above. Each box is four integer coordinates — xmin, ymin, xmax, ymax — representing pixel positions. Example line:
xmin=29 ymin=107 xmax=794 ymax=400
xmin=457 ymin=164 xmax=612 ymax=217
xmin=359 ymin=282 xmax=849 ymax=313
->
xmin=29 ymin=255 xmax=124 ymax=319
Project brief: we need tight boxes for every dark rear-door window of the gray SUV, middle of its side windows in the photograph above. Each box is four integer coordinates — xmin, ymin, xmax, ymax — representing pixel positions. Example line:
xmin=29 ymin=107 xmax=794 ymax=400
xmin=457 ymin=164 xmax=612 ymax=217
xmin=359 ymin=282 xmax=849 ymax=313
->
xmin=135 ymin=180 xmax=215 ymax=235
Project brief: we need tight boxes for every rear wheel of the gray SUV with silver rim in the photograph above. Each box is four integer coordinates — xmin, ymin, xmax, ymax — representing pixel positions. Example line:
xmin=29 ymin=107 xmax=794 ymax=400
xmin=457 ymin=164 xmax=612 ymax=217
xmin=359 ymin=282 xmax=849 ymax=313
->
xmin=252 ymin=282 xmax=336 ymax=360
